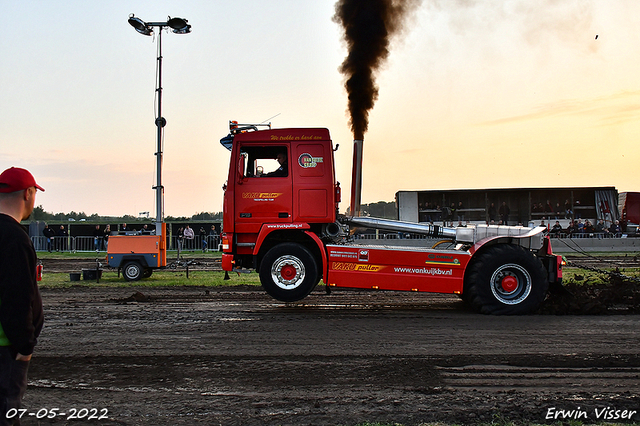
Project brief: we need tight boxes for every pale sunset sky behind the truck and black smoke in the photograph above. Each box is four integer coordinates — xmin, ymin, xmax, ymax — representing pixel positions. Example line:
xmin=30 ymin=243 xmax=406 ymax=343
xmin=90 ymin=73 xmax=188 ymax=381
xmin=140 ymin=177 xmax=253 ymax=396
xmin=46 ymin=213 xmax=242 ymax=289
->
xmin=0 ymin=0 xmax=640 ymax=216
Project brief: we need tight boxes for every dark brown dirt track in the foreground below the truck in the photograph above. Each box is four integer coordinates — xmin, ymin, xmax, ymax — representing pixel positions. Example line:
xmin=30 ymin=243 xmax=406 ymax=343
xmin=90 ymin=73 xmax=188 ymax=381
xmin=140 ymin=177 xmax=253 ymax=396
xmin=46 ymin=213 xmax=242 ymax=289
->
xmin=16 ymin=287 xmax=640 ymax=425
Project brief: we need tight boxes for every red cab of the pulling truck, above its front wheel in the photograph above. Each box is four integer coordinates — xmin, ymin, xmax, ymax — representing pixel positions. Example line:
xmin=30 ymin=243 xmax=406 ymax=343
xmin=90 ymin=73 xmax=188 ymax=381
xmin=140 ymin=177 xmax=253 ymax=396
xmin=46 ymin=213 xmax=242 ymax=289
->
xmin=222 ymin=126 xmax=340 ymax=270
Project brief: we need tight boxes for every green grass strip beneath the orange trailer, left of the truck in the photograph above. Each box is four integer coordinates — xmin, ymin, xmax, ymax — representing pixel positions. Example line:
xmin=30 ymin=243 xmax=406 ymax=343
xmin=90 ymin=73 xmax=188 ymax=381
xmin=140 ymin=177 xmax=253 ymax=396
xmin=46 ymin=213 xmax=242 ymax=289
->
xmin=39 ymin=269 xmax=260 ymax=288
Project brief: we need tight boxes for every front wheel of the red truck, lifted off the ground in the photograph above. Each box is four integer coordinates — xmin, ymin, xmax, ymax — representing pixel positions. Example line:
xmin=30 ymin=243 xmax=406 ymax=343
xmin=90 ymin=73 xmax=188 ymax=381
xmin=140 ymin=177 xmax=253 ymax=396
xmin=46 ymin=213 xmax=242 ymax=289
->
xmin=260 ymin=243 xmax=320 ymax=302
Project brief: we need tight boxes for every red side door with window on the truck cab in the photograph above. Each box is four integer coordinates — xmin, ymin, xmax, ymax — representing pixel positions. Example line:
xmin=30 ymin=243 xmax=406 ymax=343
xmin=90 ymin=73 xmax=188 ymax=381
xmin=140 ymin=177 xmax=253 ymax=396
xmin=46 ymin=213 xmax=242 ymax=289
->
xmin=235 ymin=144 xmax=292 ymax=233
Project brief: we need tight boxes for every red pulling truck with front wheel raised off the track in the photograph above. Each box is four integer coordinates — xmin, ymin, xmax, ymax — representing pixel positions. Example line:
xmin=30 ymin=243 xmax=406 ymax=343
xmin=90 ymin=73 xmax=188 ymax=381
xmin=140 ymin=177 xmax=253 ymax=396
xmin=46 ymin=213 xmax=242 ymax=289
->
xmin=221 ymin=122 xmax=562 ymax=315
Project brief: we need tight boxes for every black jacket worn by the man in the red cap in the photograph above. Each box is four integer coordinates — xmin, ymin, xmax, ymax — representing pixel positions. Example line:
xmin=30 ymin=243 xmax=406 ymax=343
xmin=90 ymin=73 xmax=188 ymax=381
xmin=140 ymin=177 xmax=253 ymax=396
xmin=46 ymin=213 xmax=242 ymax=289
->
xmin=0 ymin=213 xmax=44 ymax=355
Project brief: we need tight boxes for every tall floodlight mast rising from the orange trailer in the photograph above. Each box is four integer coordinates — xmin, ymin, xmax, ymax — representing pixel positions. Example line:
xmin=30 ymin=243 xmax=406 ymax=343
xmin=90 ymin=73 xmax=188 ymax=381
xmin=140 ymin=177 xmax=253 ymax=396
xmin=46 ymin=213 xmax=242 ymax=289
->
xmin=129 ymin=14 xmax=191 ymax=235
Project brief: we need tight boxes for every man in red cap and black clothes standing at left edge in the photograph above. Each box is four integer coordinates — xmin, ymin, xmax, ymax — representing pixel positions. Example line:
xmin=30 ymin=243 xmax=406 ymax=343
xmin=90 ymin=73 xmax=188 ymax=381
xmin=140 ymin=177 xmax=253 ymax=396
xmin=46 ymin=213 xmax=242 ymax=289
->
xmin=0 ymin=167 xmax=44 ymax=425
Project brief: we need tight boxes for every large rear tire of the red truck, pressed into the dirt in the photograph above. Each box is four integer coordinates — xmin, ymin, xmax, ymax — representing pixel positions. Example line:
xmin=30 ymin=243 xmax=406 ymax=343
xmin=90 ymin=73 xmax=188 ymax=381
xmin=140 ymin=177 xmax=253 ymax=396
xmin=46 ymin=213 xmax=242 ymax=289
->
xmin=463 ymin=244 xmax=549 ymax=315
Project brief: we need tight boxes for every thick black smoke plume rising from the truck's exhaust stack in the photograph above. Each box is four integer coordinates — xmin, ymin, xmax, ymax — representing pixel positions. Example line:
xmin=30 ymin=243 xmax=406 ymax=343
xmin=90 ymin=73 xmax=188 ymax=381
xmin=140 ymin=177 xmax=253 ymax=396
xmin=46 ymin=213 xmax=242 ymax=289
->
xmin=333 ymin=0 xmax=420 ymax=140
